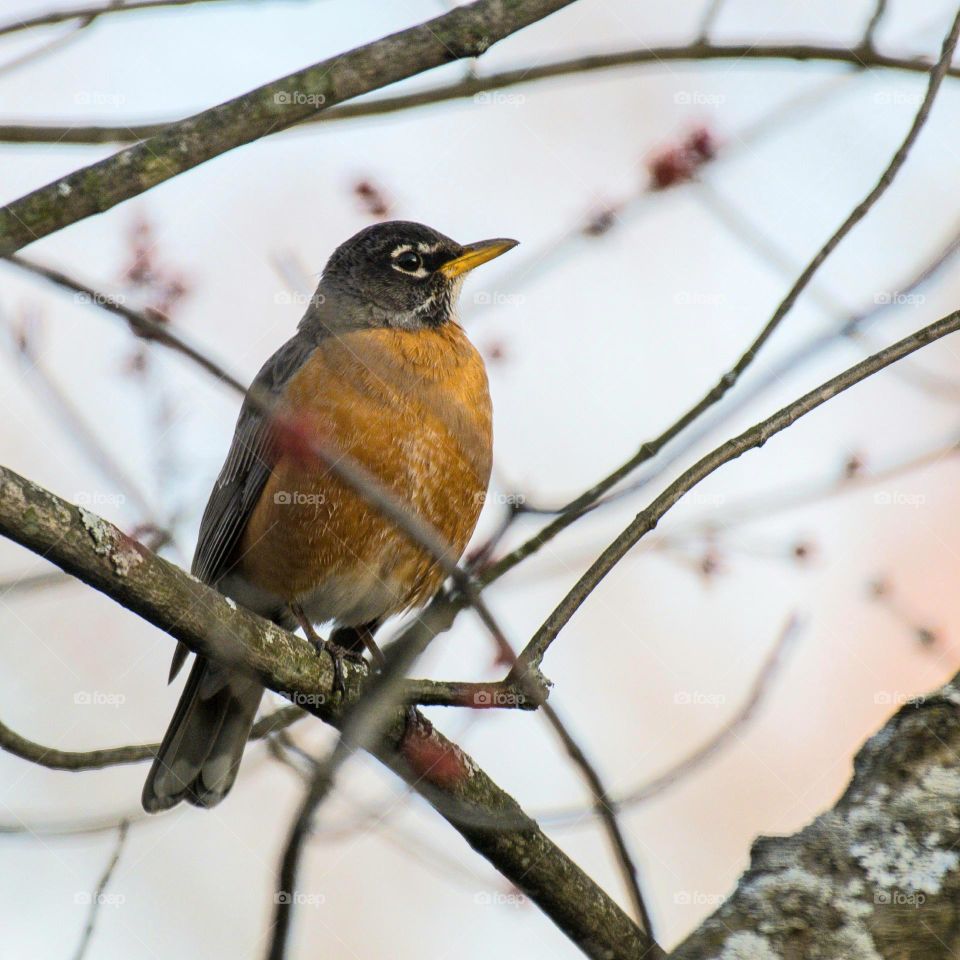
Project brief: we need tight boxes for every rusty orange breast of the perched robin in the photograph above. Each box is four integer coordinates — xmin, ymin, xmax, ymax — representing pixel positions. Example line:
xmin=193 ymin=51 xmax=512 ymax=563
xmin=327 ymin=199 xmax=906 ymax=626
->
xmin=238 ymin=322 xmax=492 ymax=619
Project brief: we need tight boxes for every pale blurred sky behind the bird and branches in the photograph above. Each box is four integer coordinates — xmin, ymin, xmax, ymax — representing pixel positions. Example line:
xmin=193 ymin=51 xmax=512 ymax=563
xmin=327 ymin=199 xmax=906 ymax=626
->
xmin=0 ymin=0 xmax=960 ymax=960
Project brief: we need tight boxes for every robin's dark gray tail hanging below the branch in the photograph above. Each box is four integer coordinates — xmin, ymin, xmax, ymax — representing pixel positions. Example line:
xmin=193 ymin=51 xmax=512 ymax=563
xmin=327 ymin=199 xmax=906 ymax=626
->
xmin=143 ymin=657 xmax=263 ymax=813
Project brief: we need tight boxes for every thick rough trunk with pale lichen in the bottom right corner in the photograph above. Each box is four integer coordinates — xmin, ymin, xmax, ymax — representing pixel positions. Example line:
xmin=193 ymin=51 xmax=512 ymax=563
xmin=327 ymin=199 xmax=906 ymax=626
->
xmin=670 ymin=677 xmax=960 ymax=960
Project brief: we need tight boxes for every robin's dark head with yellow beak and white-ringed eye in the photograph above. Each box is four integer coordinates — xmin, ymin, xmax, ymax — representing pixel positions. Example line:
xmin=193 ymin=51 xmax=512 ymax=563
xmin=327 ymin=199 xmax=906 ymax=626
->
xmin=317 ymin=220 xmax=517 ymax=330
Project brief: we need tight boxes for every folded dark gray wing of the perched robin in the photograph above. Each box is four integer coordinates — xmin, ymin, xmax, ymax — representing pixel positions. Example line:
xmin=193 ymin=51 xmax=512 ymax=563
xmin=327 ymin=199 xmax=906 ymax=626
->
xmin=170 ymin=333 xmax=317 ymax=680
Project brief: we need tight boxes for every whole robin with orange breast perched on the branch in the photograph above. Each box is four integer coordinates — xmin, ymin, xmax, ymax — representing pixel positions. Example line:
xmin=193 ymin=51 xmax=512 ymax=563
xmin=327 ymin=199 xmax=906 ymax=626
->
xmin=143 ymin=221 xmax=516 ymax=813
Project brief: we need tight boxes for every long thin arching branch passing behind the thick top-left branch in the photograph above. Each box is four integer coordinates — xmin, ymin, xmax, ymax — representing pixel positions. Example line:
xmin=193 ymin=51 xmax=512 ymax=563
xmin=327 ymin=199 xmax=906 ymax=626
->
xmin=0 ymin=42 xmax=960 ymax=144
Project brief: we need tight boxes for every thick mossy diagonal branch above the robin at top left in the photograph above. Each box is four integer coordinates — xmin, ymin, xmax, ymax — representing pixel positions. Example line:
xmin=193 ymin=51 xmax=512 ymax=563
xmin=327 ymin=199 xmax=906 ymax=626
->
xmin=0 ymin=0 xmax=573 ymax=255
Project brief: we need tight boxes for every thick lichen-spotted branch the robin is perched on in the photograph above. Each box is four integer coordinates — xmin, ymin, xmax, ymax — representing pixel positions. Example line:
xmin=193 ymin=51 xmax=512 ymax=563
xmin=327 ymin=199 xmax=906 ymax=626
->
xmin=0 ymin=468 xmax=648 ymax=960
